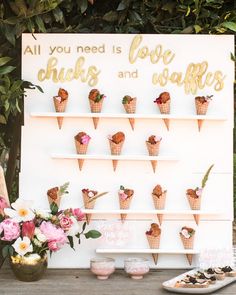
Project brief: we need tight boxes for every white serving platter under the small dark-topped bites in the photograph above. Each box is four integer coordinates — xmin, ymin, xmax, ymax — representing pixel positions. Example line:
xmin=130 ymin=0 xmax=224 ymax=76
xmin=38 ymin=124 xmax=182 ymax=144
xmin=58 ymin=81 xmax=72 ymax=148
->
xmin=162 ymin=268 xmax=236 ymax=294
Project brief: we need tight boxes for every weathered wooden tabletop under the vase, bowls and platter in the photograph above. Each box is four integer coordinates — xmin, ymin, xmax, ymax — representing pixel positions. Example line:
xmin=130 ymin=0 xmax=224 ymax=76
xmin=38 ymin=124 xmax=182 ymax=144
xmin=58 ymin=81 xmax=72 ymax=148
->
xmin=0 ymin=266 xmax=236 ymax=295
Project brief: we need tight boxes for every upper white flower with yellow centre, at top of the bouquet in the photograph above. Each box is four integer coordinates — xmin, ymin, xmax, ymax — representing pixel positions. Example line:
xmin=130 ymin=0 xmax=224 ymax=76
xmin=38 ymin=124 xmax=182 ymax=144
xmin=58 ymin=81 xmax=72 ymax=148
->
xmin=4 ymin=199 xmax=35 ymax=222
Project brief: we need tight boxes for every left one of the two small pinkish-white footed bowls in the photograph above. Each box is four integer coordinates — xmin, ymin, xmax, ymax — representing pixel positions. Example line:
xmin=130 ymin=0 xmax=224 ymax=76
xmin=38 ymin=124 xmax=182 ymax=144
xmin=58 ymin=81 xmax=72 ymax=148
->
xmin=90 ymin=257 xmax=115 ymax=280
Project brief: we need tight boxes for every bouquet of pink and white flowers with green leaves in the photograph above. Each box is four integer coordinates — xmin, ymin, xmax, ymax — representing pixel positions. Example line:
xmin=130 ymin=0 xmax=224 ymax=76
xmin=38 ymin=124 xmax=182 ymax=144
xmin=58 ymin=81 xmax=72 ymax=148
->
xmin=0 ymin=192 xmax=101 ymax=263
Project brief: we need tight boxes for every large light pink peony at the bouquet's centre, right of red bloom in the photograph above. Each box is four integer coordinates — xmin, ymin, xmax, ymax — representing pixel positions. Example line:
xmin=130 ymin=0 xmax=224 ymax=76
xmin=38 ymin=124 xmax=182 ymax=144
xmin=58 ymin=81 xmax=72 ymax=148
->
xmin=40 ymin=221 xmax=68 ymax=250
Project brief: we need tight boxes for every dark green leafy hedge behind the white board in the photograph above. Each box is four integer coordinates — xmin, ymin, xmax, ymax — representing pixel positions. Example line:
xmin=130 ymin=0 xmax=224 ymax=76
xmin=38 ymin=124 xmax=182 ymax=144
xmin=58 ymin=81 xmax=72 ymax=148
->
xmin=0 ymin=0 xmax=236 ymax=207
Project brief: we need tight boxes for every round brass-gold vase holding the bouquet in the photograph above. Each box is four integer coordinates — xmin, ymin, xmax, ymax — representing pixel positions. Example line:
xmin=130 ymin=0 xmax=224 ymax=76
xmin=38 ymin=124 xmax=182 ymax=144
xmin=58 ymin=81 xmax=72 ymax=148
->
xmin=10 ymin=255 xmax=48 ymax=282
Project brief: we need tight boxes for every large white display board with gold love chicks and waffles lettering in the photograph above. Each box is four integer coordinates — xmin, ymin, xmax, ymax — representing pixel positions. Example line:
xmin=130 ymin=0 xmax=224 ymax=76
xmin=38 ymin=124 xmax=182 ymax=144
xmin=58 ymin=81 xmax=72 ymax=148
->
xmin=20 ymin=34 xmax=234 ymax=268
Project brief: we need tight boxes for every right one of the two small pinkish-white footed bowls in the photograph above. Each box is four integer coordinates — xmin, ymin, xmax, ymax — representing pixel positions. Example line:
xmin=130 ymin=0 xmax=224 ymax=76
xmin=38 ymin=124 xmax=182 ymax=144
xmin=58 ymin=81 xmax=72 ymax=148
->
xmin=125 ymin=258 xmax=149 ymax=280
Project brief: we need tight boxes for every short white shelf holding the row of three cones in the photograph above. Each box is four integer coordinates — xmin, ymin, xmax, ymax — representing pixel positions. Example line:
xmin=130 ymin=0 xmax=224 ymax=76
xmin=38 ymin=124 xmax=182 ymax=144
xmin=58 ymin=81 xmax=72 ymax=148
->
xmin=51 ymin=153 xmax=178 ymax=161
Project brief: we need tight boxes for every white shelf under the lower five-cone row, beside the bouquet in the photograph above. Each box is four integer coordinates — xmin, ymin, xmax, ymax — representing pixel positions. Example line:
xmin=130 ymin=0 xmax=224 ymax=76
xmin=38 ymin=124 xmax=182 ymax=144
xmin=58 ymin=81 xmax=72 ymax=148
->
xmin=82 ymin=209 xmax=220 ymax=215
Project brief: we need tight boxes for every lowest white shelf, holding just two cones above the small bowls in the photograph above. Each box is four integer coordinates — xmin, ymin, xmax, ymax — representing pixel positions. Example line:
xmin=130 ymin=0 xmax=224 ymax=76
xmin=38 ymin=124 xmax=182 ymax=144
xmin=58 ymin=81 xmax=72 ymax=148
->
xmin=96 ymin=248 xmax=200 ymax=254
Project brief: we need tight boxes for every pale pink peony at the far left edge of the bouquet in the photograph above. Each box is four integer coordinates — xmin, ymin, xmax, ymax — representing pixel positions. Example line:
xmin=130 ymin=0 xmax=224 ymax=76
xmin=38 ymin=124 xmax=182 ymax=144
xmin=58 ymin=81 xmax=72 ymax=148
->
xmin=0 ymin=218 xmax=20 ymax=241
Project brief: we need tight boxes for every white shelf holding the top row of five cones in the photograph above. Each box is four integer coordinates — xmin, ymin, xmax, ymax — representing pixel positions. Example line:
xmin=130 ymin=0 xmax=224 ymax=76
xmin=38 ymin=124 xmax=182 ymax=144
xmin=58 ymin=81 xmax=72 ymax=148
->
xmin=30 ymin=112 xmax=227 ymax=121
